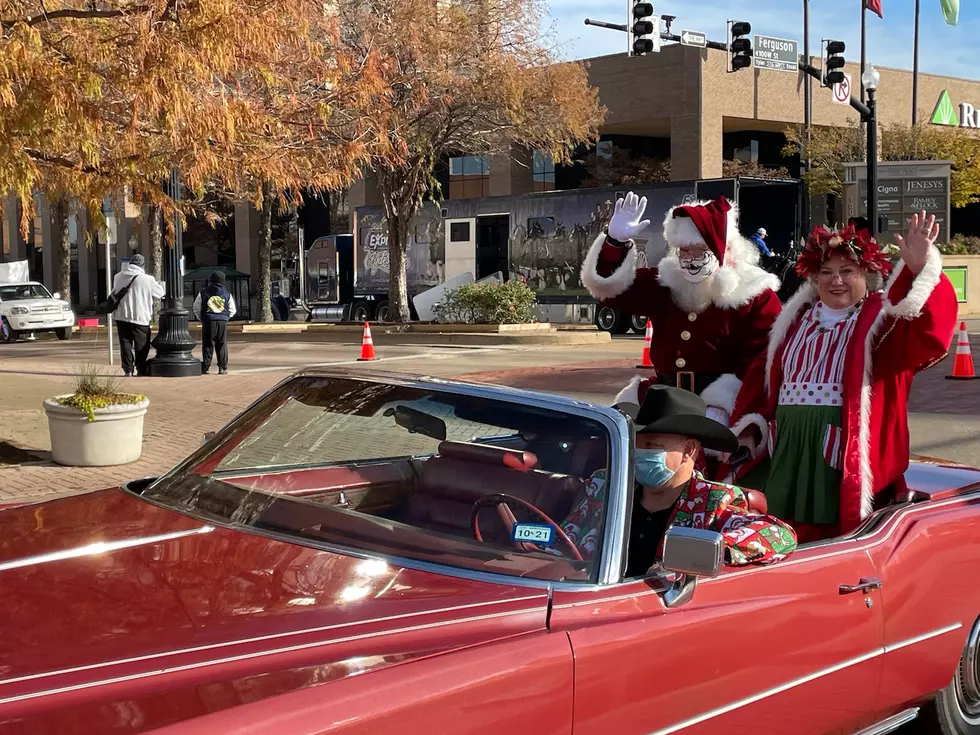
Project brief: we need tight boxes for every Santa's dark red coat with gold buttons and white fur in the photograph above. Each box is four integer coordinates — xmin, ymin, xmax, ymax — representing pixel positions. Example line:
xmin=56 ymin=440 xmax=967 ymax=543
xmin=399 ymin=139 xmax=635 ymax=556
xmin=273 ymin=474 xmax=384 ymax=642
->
xmin=582 ymin=227 xmax=781 ymax=414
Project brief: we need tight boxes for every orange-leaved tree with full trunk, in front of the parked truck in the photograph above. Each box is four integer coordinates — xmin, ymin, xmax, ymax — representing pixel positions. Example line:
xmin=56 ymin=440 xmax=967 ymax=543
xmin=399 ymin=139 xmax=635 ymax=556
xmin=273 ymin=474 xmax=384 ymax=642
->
xmin=333 ymin=0 xmax=604 ymax=321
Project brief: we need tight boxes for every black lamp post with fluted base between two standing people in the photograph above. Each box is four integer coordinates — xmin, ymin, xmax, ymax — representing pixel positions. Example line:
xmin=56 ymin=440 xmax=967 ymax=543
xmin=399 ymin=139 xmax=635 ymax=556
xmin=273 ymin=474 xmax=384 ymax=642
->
xmin=149 ymin=170 xmax=201 ymax=378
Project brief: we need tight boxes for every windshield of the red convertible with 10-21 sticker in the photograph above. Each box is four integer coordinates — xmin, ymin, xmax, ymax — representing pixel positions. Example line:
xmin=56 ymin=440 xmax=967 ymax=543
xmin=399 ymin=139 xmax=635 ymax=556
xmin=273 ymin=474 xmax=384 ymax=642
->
xmin=143 ymin=376 xmax=610 ymax=580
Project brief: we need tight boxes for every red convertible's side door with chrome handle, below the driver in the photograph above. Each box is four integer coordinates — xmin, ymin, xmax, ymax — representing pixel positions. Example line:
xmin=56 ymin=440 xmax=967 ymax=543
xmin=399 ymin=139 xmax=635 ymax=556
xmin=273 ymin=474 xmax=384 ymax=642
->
xmin=551 ymin=541 xmax=882 ymax=735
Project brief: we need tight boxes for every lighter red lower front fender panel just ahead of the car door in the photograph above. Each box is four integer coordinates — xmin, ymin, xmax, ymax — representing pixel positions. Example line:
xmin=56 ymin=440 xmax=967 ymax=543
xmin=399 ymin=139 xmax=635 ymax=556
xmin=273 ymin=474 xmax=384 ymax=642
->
xmin=145 ymin=633 xmax=573 ymax=735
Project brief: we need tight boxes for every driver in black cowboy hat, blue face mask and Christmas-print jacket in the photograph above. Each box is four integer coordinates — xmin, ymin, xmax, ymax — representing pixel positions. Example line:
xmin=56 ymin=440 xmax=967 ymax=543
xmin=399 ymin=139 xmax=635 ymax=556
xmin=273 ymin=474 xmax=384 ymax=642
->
xmin=562 ymin=385 xmax=796 ymax=578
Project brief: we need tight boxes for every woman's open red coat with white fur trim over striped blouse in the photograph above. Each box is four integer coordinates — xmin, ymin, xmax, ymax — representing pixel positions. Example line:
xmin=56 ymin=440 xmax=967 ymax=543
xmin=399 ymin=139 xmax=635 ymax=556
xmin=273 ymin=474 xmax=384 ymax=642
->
xmin=732 ymin=248 xmax=957 ymax=533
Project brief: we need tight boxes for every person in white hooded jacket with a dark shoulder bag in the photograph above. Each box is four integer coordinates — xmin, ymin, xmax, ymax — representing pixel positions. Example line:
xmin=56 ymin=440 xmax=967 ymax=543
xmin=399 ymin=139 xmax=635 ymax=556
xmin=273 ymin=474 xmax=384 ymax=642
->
xmin=112 ymin=253 xmax=166 ymax=376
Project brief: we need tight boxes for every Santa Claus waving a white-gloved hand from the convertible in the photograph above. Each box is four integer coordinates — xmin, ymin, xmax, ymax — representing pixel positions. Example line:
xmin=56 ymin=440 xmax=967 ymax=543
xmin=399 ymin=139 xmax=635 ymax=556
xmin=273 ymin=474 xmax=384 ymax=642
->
xmin=582 ymin=192 xmax=780 ymax=426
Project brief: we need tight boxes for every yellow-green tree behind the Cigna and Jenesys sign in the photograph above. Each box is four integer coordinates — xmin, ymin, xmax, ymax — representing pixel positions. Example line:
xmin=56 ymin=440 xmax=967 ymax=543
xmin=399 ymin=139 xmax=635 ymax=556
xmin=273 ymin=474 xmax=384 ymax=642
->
xmin=783 ymin=123 xmax=980 ymax=207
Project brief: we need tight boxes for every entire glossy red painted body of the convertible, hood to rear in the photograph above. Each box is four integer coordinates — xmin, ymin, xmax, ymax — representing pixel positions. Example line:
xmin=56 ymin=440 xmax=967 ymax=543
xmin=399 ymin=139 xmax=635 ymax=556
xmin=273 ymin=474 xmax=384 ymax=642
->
xmin=0 ymin=374 xmax=980 ymax=735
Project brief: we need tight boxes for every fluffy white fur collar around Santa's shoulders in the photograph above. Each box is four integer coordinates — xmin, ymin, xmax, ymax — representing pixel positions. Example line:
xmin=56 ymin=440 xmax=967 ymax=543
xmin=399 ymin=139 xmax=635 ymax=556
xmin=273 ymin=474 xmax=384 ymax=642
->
xmin=657 ymin=253 xmax=779 ymax=314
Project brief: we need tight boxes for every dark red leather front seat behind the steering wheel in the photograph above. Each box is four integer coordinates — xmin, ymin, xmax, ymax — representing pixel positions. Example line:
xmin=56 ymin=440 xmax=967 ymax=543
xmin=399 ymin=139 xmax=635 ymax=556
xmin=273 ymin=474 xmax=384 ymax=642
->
xmin=402 ymin=442 xmax=583 ymax=542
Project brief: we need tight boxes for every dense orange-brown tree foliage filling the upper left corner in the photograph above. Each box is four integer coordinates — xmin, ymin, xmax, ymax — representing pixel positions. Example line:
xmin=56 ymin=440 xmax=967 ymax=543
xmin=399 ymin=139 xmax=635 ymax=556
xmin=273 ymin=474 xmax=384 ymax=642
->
xmin=0 ymin=0 xmax=373 ymax=310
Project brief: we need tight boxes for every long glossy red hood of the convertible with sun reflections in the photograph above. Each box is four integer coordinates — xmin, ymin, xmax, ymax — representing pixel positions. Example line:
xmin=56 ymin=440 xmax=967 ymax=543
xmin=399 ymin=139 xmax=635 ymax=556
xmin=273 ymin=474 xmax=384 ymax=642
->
xmin=0 ymin=490 xmax=547 ymax=732
